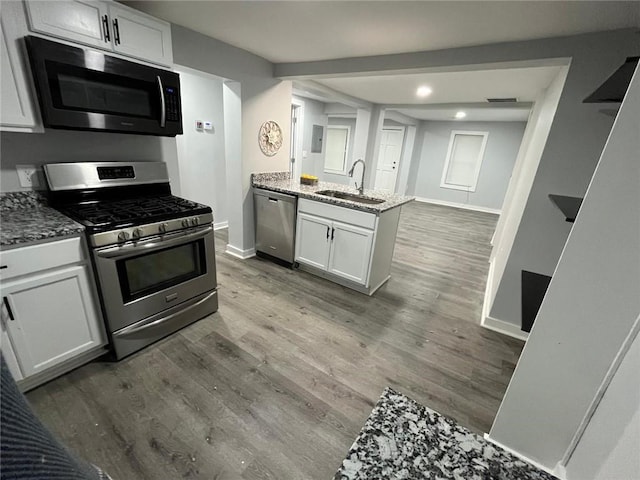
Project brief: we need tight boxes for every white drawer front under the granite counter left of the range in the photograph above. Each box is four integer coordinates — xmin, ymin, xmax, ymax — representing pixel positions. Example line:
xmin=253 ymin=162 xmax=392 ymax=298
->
xmin=0 ymin=237 xmax=84 ymax=280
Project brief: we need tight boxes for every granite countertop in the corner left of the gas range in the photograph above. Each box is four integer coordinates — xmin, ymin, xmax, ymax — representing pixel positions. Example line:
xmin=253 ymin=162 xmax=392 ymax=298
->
xmin=0 ymin=192 xmax=84 ymax=248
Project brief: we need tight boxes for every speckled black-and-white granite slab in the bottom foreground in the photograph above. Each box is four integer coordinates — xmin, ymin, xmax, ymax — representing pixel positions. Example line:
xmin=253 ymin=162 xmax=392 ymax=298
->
xmin=334 ymin=388 xmax=556 ymax=480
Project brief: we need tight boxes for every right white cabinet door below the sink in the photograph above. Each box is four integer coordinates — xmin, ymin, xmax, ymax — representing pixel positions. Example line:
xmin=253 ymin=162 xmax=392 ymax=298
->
xmin=328 ymin=222 xmax=373 ymax=285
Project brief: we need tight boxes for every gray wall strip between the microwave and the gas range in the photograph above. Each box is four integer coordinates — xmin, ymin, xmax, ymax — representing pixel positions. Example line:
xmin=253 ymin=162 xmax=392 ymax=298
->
xmin=0 ymin=129 xmax=180 ymax=195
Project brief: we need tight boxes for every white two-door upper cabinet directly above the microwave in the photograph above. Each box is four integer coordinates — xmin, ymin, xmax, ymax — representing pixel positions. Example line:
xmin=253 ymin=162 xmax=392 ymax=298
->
xmin=26 ymin=0 xmax=173 ymax=66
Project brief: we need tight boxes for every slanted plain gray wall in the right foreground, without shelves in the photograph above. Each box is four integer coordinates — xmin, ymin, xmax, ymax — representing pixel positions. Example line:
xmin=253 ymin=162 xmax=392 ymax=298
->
xmin=491 ymin=65 xmax=640 ymax=468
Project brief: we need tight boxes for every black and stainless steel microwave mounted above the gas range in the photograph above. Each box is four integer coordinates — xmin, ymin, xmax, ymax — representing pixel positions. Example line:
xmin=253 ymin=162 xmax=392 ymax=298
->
xmin=25 ymin=36 xmax=182 ymax=137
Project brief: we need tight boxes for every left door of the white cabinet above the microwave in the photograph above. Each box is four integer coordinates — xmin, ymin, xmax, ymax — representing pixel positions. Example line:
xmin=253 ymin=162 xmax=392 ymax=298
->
xmin=26 ymin=0 xmax=112 ymax=50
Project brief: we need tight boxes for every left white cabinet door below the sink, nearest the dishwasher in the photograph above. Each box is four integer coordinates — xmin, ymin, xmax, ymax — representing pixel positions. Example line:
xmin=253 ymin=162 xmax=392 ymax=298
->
xmin=296 ymin=213 xmax=331 ymax=270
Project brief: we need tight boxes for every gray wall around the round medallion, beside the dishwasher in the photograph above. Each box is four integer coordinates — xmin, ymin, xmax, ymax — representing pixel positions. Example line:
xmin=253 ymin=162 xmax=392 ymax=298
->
xmin=171 ymin=25 xmax=292 ymax=257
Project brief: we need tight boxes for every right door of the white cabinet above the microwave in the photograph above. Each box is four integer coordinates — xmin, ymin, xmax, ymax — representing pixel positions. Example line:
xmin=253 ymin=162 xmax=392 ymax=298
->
xmin=109 ymin=4 xmax=173 ymax=65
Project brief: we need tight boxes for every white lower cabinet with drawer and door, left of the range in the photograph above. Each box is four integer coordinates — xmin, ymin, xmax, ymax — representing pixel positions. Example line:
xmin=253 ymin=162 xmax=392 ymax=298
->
xmin=0 ymin=238 xmax=107 ymax=387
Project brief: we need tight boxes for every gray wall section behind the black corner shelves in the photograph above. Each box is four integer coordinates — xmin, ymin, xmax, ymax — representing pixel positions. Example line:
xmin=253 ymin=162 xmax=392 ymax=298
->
xmin=490 ymin=31 xmax=640 ymax=325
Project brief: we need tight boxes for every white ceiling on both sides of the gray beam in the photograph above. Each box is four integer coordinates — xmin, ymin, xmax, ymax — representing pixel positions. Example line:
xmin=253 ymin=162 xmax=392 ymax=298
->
xmin=122 ymin=0 xmax=640 ymax=121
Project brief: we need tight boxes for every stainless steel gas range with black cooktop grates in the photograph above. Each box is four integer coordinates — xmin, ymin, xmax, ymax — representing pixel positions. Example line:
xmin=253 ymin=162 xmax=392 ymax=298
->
xmin=44 ymin=162 xmax=218 ymax=359
